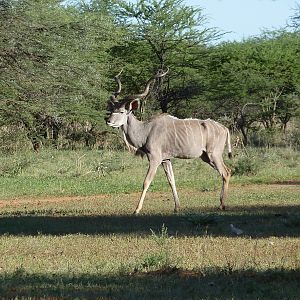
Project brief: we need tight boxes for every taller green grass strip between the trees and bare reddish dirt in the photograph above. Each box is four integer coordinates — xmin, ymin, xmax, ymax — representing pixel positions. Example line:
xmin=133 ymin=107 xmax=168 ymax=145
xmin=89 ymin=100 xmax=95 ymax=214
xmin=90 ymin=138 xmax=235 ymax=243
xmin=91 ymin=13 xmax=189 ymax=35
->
xmin=0 ymin=149 xmax=300 ymax=199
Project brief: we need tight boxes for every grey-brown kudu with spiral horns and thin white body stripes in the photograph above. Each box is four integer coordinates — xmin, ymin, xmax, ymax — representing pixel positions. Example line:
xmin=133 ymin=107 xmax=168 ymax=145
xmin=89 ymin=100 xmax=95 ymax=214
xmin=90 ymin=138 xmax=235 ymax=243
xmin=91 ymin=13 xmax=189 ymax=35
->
xmin=106 ymin=71 xmax=231 ymax=214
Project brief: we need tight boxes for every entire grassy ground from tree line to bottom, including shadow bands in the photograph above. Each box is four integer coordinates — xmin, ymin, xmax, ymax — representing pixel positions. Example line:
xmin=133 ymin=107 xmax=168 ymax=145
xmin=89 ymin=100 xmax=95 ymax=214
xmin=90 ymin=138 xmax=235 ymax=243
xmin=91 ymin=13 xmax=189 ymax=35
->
xmin=0 ymin=149 xmax=300 ymax=299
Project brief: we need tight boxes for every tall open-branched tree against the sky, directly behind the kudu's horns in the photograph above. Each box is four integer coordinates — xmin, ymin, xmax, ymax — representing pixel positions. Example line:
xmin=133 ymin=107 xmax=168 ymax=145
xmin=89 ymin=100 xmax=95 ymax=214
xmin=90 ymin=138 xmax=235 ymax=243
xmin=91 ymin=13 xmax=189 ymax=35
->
xmin=113 ymin=0 xmax=219 ymax=112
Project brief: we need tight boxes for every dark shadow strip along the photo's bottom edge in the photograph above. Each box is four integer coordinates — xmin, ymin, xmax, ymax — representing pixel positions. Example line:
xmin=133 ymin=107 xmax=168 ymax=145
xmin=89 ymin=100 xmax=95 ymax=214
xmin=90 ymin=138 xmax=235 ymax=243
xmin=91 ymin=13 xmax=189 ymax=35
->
xmin=0 ymin=269 xmax=300 ymax=300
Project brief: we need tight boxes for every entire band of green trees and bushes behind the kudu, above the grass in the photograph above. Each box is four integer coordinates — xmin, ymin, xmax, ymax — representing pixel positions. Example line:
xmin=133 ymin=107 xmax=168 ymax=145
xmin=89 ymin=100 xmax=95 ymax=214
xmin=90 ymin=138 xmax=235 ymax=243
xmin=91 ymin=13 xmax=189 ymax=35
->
xmin=0 ymin=0 xmax=300 ymax=151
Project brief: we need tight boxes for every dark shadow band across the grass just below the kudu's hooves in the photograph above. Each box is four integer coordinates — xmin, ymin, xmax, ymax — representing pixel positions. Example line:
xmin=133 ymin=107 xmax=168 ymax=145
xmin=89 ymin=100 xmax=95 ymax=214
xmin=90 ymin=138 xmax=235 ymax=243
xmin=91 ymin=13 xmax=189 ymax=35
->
xmin=0 ymin=205 xmax=300 ymax=238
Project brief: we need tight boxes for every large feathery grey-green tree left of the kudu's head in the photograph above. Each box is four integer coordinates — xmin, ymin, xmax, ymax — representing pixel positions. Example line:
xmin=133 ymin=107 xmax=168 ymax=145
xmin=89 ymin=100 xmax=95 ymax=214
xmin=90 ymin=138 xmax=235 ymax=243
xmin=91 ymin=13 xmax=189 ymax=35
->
xmin=0 ymin=0 xmax=122 ymax=149
